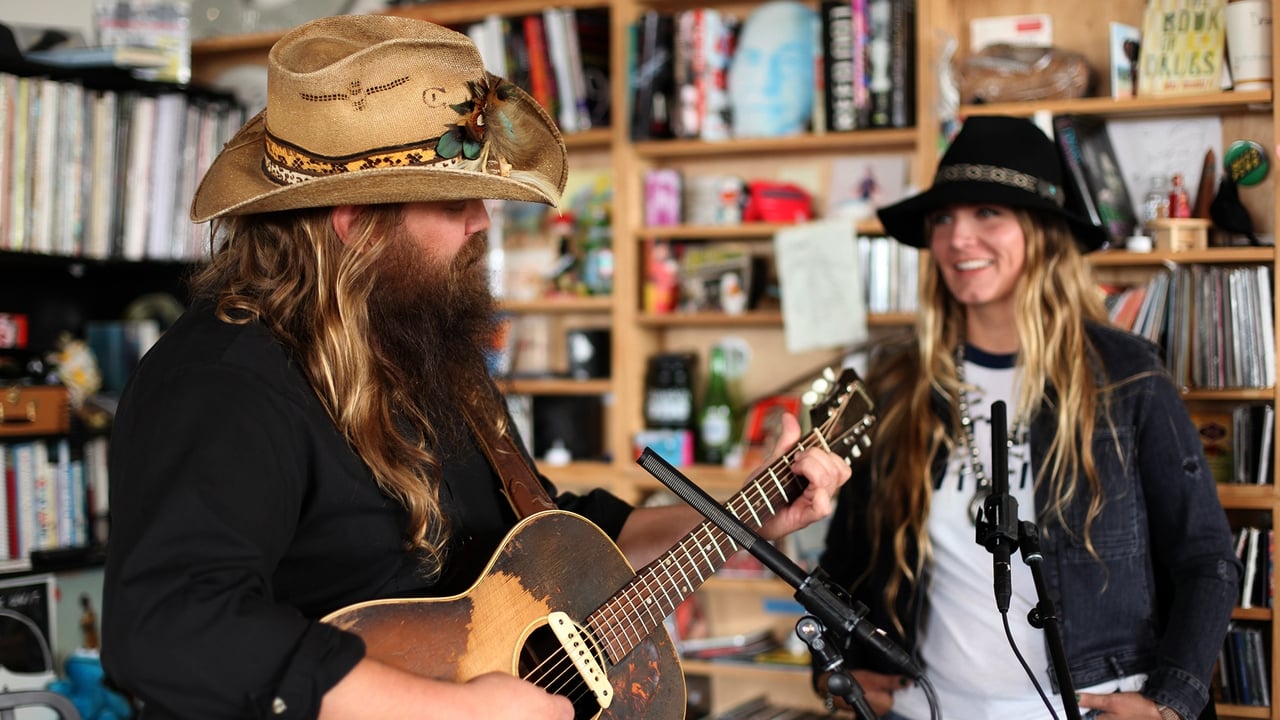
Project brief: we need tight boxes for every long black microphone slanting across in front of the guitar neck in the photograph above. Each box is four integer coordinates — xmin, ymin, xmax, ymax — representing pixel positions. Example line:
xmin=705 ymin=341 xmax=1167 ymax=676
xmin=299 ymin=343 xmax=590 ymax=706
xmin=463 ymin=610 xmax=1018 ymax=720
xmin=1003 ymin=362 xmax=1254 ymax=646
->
xmin=636 ymin=447 xmax=924 ymax=679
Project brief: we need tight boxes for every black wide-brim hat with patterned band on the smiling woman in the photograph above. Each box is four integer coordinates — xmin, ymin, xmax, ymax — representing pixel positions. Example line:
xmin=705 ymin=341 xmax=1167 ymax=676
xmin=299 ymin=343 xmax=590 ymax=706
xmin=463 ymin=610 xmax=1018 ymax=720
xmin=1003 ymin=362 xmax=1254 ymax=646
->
xmin=878 ymin=115 xmax=1108 ymax=252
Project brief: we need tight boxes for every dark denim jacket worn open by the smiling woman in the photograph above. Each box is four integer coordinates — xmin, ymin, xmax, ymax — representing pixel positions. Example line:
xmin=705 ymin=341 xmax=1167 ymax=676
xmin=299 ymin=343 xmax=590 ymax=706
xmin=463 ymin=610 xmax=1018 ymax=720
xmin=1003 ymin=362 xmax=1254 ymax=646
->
xmin=820 ymin=324 xmax=1240 ymax=719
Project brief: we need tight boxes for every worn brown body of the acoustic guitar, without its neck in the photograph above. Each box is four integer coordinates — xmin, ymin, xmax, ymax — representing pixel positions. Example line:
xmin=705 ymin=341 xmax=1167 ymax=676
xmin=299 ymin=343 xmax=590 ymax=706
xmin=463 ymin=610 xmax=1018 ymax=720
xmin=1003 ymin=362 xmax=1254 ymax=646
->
xmin=325 ymin=510 xmax=685 ymax=720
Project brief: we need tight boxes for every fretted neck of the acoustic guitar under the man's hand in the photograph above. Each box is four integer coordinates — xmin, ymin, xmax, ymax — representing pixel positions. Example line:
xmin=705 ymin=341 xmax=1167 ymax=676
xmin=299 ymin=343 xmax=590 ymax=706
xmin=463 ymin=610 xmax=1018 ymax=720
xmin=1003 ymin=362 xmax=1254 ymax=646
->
xmin=586 ymin=433 xmax=822 ymax=662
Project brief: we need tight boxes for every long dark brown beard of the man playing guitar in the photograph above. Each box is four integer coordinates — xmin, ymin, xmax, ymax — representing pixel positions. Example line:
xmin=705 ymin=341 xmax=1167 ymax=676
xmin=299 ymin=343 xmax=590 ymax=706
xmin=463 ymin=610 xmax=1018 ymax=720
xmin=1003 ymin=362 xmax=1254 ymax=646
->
xmin=369 ymin=233 xmax=498 ymax=452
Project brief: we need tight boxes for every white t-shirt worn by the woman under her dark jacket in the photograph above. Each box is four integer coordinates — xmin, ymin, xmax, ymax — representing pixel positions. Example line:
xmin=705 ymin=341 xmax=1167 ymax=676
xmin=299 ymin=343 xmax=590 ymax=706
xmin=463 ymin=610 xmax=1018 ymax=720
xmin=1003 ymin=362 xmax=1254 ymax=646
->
xmin=893 ymin=351 xmax=1146 ymax=720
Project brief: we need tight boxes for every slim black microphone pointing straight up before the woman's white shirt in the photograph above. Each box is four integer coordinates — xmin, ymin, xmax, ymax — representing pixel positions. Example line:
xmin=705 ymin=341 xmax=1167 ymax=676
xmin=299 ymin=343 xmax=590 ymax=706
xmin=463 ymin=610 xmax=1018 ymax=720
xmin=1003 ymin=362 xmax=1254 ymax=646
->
xmin=977 ymin=400 xmax=1018 ymax=612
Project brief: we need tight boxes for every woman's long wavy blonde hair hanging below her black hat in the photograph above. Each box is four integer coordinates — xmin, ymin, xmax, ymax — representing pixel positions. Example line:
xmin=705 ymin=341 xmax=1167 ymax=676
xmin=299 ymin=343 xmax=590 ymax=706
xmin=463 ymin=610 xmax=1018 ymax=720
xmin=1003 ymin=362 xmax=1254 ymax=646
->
xmin=868 ymin=210 xmax=1110 ymax=623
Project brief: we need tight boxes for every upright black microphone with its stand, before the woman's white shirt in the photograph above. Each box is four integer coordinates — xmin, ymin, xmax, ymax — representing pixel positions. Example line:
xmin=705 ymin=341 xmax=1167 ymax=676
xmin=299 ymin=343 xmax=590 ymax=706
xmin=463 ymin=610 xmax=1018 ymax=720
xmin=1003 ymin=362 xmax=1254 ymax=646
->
xmin=974 ymin=400 xmax=1080 ymax=720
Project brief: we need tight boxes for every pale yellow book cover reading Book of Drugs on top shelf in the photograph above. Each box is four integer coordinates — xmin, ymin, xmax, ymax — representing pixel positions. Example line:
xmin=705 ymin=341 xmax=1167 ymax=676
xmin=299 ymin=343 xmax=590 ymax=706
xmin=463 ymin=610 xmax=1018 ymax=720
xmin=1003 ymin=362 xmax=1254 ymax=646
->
xmin=1138 ymin=0 xmax=1226 ymax=97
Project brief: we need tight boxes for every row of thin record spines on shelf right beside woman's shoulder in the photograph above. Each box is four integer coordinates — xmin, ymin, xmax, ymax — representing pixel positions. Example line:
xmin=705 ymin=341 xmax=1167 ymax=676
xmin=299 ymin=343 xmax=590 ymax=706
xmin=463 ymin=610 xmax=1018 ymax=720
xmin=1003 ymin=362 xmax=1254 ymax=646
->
xmin=1107 ymin=264 xmax=1276 ymax=388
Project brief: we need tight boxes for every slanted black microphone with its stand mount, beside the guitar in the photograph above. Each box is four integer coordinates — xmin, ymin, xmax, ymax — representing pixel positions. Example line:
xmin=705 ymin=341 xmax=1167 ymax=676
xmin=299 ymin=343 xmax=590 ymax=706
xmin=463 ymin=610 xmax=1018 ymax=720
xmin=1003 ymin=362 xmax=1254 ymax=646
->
xmin=636 ymin=447 xmax=924 ymax=720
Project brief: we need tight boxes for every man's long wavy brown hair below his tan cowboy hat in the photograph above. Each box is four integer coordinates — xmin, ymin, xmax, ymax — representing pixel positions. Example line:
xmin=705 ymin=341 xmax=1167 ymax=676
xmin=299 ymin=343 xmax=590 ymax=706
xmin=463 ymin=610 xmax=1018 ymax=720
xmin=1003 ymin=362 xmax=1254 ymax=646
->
xmin=192 ymin=205 xmax=483 ymax=574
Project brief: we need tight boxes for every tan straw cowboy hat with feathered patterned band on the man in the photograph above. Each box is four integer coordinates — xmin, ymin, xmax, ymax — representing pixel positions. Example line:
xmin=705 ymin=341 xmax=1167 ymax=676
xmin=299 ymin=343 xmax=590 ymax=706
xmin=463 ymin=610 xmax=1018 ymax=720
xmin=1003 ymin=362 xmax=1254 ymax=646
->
xmin=191 ymin=15 xmax=568 ymax=223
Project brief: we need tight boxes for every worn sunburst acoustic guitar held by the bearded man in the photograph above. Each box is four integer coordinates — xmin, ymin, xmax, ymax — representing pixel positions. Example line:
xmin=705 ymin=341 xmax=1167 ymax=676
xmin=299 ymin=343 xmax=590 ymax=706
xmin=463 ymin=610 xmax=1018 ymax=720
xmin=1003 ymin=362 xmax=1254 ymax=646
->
xmin=324 ymin=369 xmax=876 ymax=720
